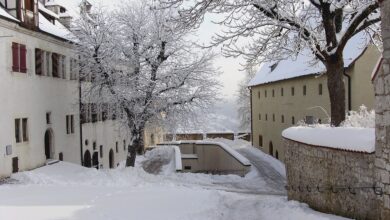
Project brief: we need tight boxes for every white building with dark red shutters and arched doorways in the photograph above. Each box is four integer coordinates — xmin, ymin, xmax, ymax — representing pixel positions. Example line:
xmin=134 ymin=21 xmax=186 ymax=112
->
xmin=0 ymin=0 xmax=130 ymax=178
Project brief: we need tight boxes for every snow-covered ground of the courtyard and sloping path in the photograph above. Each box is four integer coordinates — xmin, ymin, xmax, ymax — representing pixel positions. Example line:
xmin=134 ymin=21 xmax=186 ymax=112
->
xmin=0 ymin=140 xmax=350 ymax=220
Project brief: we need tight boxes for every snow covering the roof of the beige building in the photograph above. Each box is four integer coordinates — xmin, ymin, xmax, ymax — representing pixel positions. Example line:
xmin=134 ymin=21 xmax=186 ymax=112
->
xmin=248 ymin=34 xmax=367 ymax=86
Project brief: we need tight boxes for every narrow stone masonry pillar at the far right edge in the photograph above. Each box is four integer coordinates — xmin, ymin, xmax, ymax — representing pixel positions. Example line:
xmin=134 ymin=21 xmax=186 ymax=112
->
xmin=374 ymin=0 xmax=390 ymax=219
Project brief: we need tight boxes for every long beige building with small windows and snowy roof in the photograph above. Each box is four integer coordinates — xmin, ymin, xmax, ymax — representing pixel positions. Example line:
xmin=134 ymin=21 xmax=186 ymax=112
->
xmin=249 ymin=37 xmax=380 ymax=161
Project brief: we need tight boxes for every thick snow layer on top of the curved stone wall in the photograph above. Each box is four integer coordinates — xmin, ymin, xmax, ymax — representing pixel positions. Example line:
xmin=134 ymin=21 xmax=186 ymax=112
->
xmin=282 ymin=127 xmax=375 ymax=153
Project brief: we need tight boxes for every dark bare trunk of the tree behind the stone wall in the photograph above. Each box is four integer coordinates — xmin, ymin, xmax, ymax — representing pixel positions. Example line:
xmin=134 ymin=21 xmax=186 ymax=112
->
xmin=327 ymin=55 xmax=346 ymax=127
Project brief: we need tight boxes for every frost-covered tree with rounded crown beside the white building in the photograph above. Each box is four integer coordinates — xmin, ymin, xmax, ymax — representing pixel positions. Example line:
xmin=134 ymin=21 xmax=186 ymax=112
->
xmin=75 ymin=1 xmax=218 ymax=166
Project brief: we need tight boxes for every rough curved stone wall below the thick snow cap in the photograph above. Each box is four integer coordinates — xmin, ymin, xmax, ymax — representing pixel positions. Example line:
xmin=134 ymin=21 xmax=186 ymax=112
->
xmin=284 ymin=139 xmax=378 ymax=219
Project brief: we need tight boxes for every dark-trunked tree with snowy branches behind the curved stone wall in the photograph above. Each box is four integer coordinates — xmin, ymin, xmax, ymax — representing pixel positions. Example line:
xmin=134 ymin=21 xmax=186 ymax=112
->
xmin=160 ymin=0 xmax=380 ymax=126
